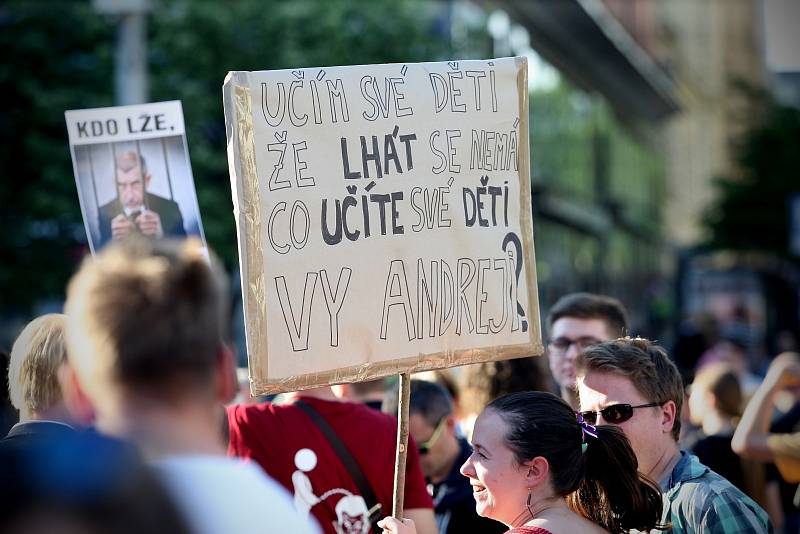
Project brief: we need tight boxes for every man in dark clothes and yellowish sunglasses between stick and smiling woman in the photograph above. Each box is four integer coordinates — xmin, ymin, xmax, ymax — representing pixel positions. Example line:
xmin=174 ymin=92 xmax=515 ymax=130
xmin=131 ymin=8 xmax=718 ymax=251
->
xmin=384 ymin=379 xmax=508 ymax=534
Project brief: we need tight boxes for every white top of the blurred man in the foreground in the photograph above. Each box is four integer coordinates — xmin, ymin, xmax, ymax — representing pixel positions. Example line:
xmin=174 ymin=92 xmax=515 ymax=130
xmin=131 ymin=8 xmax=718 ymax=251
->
xmin=152 ymin=455 xmax=319 ymax=534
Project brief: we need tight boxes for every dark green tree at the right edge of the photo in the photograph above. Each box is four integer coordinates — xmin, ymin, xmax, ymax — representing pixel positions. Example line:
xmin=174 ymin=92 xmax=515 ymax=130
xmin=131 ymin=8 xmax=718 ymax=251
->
xmin=704 ymin=104 xmax=800 ymax=256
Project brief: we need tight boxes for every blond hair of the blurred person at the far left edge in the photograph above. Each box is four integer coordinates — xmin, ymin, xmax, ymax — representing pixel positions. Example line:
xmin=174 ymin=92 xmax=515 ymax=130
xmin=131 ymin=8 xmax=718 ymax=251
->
xmin=8 ymin=313 xmax=67 ymax=418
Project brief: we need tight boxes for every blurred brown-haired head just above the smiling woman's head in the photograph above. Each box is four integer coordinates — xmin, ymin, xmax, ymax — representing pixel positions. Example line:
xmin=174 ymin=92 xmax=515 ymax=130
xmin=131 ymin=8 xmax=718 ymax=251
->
xmin=459 ymin=357 xmax=550 ymax=438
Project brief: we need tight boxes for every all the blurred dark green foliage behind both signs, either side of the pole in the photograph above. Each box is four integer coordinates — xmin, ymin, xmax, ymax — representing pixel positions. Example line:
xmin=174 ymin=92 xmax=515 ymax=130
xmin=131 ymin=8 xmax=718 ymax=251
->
xmin=0 ymin=0 xmax=449 ymax=311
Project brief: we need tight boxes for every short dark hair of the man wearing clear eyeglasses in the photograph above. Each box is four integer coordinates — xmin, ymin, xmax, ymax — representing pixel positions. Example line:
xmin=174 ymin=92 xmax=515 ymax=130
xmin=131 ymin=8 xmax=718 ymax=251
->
xmin=547 ymin=293 xmax=628 ymax=338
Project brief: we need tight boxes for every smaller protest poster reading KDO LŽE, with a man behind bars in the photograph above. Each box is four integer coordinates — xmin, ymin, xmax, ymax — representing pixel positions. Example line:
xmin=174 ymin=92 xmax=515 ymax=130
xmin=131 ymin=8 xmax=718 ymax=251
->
xmin=65 ymin=101 xmax=205 ymax=254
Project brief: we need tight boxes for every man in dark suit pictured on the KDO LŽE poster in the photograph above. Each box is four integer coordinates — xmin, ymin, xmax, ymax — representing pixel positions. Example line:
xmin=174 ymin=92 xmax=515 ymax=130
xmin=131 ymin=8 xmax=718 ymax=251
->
xmin=98 ymin=150 xmax=186 ymax=248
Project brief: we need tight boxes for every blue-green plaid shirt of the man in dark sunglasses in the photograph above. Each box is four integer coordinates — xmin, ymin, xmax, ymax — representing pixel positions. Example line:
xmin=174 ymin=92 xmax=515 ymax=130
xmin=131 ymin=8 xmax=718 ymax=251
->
xmin=661 ymin=451 xmax=774 ymax=534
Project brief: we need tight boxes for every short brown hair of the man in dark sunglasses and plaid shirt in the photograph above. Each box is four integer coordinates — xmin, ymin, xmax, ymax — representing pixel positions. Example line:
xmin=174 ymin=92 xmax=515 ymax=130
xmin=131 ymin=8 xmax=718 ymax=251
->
xmin=575 ymin=337 xmax=684 ymax=441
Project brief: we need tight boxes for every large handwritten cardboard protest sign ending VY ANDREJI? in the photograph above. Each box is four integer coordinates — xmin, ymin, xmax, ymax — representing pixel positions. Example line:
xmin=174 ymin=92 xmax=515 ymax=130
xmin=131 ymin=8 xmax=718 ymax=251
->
xmin=223 ymin=58 xmax=542 ymax=393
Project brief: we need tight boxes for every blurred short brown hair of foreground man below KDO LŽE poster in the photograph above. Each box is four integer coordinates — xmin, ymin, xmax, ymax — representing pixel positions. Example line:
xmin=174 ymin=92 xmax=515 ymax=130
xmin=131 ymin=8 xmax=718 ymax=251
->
xmin=66 ymin=239 xmax=228 ymax=402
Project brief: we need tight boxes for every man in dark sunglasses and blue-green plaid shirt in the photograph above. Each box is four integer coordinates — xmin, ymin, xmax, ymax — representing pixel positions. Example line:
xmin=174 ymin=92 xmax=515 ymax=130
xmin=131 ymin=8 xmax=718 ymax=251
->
xmin=575 ymin=338 xmax=773 ymax=534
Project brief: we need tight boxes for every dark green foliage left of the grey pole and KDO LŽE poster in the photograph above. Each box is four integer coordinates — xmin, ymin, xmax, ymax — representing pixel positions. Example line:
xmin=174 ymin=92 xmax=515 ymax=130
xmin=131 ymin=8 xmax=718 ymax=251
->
xmin=0 ymin=1 xmax=114 ymax=309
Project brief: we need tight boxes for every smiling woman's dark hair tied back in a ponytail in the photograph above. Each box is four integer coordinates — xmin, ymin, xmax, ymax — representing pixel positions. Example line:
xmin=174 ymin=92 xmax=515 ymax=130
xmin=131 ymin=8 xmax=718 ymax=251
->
xmin=486 ymin=391 xmax=670 ymax=534
